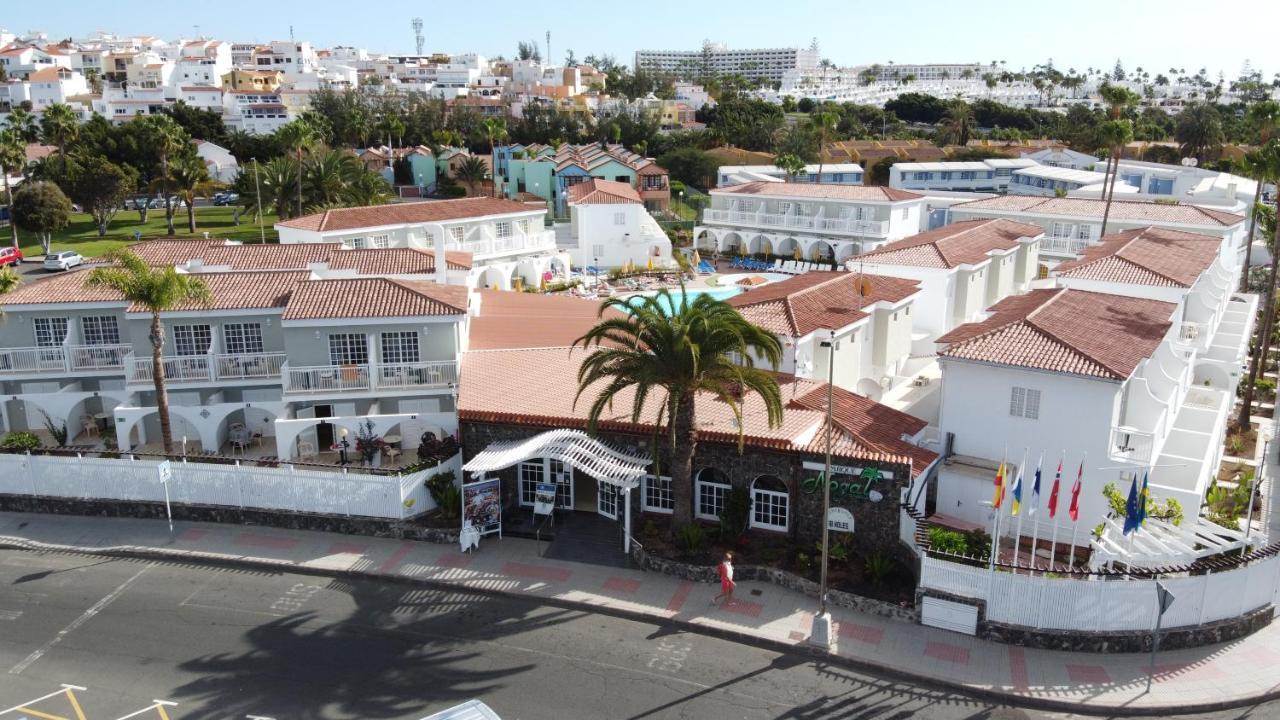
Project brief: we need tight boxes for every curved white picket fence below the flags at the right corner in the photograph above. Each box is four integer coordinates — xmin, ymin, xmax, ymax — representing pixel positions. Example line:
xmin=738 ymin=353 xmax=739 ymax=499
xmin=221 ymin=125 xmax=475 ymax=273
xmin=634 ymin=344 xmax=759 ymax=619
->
xmin=920 ymin=548 xmax=1280 ymax=630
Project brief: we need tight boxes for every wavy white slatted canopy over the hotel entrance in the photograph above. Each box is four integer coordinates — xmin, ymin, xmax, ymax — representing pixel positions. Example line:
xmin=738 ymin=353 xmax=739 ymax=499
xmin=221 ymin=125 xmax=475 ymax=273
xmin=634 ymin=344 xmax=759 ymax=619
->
xmin=462 ymin=429 xmax=650 ymax=489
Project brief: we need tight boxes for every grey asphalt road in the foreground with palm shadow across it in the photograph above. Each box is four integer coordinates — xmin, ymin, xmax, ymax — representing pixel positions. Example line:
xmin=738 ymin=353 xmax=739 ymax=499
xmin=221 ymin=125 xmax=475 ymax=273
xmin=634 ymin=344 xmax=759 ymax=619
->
xmin=0 ymin=543 xmax=1280 ymax=720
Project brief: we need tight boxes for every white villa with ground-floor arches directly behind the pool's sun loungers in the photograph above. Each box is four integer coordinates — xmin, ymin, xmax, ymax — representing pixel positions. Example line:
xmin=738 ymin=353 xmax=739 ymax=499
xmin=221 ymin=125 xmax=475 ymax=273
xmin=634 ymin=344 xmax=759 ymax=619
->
xmin=694 ymin=182 xmax=924 ymax=263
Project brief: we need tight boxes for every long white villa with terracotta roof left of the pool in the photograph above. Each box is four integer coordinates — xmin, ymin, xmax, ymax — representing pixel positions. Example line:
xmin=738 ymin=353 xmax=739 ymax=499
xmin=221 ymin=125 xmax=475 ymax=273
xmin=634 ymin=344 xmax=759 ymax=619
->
xmin=275 ymin=197 xmax=568 ymax=290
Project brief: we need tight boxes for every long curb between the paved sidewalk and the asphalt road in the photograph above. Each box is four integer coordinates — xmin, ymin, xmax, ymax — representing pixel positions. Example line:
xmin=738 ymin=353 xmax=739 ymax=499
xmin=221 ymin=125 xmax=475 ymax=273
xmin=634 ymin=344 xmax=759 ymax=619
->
xmin=0 ymin=536 xmax=1280 ymax=717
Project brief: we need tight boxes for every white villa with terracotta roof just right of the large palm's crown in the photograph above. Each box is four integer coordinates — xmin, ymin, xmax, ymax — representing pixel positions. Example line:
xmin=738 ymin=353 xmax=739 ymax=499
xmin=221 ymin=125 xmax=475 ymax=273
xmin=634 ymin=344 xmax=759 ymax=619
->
xmin=728 ymin=272 xmax=919 ymax=400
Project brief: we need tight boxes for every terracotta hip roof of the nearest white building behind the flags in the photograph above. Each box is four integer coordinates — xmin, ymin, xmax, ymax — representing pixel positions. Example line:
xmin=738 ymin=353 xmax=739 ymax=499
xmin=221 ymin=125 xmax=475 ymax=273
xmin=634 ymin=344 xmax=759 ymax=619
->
xmin=937 ymin=288 xmax=1178 ymax=380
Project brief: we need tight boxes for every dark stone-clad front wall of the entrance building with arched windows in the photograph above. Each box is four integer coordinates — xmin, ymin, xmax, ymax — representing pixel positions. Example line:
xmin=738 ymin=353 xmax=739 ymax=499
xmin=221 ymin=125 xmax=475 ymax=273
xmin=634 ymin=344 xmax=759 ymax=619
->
xmin=460 ymin=420 xmax=913 ymax=556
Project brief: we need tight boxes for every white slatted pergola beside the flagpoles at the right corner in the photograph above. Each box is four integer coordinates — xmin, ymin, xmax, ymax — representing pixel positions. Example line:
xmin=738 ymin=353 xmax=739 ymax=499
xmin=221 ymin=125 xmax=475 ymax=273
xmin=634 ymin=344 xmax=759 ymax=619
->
xmin=1089 ymin=516 xmax=1267 ymax=570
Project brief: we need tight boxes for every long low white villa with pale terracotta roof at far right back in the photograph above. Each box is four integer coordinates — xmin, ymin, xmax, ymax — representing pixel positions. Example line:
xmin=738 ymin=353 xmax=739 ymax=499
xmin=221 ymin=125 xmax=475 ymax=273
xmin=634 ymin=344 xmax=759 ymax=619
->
xmin=950 ymin=195 xmax=1247 ymax=268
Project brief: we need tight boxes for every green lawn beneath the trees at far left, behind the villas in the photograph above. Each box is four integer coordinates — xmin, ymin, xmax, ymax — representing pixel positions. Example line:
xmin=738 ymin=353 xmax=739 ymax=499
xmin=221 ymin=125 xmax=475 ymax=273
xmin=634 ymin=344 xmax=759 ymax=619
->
xmin=18 ymin=208 xmax=276 ymax=258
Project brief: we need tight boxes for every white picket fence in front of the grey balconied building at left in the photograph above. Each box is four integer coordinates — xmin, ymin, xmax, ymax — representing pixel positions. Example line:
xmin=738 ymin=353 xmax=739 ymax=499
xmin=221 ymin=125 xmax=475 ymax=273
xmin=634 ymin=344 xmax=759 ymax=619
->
xmin=0 ymin=455 xmax=462 ymax=520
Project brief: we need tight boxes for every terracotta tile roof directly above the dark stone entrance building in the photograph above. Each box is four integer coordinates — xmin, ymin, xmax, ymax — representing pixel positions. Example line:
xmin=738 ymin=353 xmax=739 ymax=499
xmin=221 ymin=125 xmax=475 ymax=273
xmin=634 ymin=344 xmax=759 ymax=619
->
xmin=458 ymin=345 xmax=936 ymax=474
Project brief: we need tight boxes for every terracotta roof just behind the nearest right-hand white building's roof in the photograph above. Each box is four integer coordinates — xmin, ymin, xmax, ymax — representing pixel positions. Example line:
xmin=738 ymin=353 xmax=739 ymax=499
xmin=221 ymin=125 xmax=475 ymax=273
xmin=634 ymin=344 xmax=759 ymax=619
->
xmin=1051 ymin=228 xmax=1222 ymax=287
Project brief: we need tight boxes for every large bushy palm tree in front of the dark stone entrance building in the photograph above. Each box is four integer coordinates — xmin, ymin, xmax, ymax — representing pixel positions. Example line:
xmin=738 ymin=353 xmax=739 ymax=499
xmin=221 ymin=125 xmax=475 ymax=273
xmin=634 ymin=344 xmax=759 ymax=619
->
xmin=573 ymin=290 xmax=782 ymax=527
